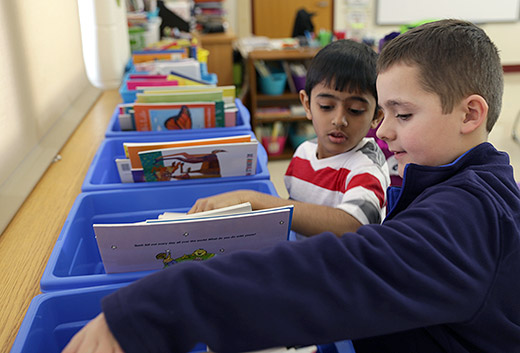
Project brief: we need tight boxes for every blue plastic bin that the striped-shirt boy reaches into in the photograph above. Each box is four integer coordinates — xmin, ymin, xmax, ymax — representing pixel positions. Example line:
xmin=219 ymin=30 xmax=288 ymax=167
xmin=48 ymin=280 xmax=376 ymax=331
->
xmin=40 ymin=180 xmax=278 ymax=292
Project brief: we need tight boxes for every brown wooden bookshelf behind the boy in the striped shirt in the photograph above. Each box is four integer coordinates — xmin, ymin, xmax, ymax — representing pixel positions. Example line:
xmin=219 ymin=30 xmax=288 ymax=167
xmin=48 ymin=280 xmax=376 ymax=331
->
xmin=246 ymin=47 xmax=320 ymax=160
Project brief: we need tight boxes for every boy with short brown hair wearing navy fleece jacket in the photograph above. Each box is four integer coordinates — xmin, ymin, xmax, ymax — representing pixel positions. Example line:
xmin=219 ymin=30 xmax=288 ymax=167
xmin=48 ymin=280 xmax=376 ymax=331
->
xmin=65 ymin=20 xmax=520 ymax=353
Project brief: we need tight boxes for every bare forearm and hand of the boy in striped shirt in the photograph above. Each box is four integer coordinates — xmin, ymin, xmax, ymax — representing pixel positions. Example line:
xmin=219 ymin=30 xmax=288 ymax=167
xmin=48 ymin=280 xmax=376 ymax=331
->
xmin=188 ymin=190 xmax=361 ymax=236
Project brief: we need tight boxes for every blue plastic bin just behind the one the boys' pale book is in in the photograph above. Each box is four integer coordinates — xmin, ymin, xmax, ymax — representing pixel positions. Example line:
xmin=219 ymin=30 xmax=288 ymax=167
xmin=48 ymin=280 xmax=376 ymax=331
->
xmin=81 ymin=130 xmax=270 ymax=191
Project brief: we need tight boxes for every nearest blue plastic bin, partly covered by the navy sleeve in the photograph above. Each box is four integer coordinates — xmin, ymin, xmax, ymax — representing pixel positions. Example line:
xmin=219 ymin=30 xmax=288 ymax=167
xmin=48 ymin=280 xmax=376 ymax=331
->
xmin=11 ymin=283 xmax=207 ymax=353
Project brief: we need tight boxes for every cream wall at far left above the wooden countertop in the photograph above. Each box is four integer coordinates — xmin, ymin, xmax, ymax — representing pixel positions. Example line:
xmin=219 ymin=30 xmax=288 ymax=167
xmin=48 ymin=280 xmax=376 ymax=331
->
xmin=0 ymin=0 xmax=100 ymax=236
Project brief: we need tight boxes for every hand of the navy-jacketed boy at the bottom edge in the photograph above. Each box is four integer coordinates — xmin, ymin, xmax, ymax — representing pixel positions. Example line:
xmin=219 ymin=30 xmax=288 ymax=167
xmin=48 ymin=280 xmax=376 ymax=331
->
xmin=62 ymin=313 xmax=124 ymax=353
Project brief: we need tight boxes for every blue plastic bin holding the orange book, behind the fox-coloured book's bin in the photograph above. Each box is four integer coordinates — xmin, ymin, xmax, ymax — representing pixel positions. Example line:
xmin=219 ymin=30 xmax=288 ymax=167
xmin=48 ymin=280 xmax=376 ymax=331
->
xmin=105 ymin=98 xmax=251 ymax=137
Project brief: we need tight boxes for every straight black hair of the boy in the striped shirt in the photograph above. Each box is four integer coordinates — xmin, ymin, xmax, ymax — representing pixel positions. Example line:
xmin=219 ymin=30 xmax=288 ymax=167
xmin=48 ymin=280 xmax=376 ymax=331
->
xmin=305 ymin=39 xmax=377 ymax=102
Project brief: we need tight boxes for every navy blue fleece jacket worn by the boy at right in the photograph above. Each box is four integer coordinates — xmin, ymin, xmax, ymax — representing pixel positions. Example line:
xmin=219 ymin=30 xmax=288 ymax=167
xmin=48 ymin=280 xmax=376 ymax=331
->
xmin=102 ymin=143 xmax=520 ymax=353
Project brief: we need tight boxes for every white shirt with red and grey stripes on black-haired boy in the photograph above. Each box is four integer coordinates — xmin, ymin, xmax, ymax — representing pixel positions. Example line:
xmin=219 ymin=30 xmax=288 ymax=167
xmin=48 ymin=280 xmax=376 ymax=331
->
xmin=284 ymin=137 xmax=390 ymax=236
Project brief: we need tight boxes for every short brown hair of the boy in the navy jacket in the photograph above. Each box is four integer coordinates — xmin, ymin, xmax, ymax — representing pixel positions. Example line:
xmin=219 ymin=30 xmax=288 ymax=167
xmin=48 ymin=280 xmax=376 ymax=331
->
xmin=377 ymin=19 xmax=504 ymax=132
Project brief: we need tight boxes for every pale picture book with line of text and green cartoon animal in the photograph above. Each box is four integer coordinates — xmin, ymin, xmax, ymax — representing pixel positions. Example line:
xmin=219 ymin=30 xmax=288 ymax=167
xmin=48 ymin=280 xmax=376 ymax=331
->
xmin=93 ymin=206 xmax=293 ymax=273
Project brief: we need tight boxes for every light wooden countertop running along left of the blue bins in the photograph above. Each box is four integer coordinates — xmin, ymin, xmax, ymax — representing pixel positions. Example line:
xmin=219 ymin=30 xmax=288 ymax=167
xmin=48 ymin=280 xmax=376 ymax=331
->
xmin=0 ymin=90 xmax=121 ymax=352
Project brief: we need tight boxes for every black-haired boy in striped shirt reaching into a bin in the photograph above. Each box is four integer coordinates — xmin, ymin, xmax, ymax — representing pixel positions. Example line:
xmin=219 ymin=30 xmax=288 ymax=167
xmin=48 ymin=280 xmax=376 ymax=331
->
xmin=190 ymin=40 xmax=390 ymax=238
